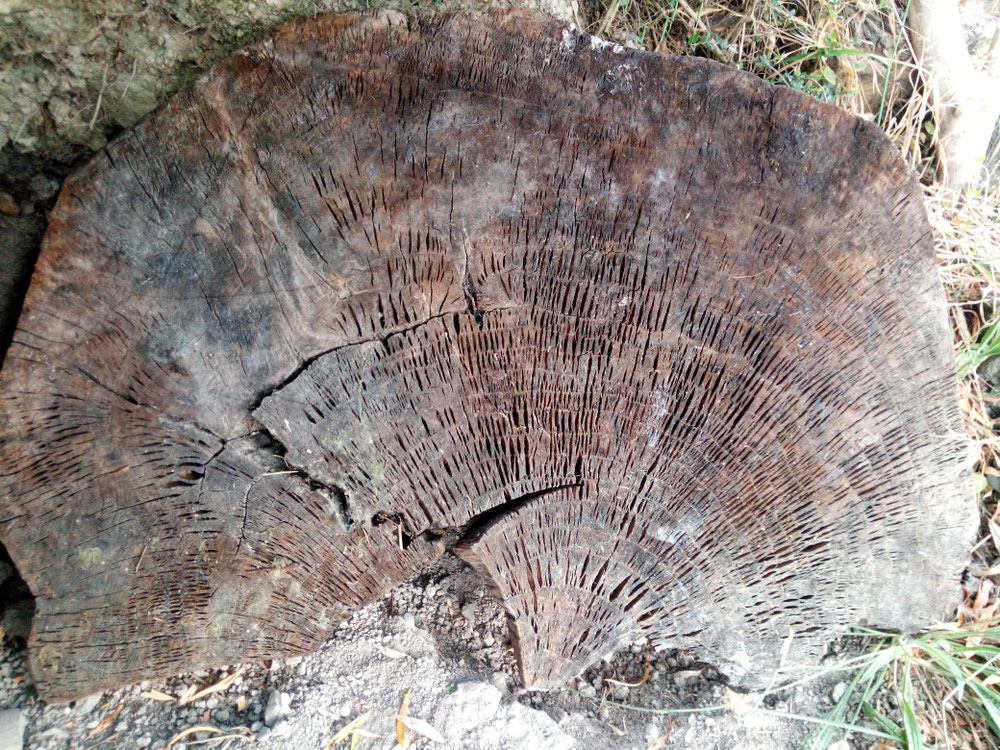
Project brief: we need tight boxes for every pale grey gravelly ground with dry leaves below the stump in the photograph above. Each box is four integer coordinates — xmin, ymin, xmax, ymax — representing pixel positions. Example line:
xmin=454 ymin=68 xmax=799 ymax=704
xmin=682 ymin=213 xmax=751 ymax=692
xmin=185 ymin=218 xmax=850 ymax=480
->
xmin=0 ymin=556 xmax=861 ymax=750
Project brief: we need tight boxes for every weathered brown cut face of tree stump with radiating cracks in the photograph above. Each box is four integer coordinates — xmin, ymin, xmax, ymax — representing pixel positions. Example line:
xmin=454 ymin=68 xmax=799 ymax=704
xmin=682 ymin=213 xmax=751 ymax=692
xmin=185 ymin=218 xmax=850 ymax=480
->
xmin=0 ymin=7 xmax=973 ymax=699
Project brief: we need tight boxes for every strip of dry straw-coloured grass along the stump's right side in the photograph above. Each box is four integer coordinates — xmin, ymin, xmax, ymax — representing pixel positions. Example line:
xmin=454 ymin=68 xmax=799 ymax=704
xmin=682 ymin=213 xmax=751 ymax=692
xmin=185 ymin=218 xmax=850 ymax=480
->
xmin=932 ymin=185 xmax=1000 ymax=748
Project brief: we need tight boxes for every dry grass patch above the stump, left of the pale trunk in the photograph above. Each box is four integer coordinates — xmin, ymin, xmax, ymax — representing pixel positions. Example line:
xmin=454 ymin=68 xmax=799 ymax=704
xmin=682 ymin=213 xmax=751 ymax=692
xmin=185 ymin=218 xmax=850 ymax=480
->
xmin=587 ymin=0 xmax=933 ymax=175
